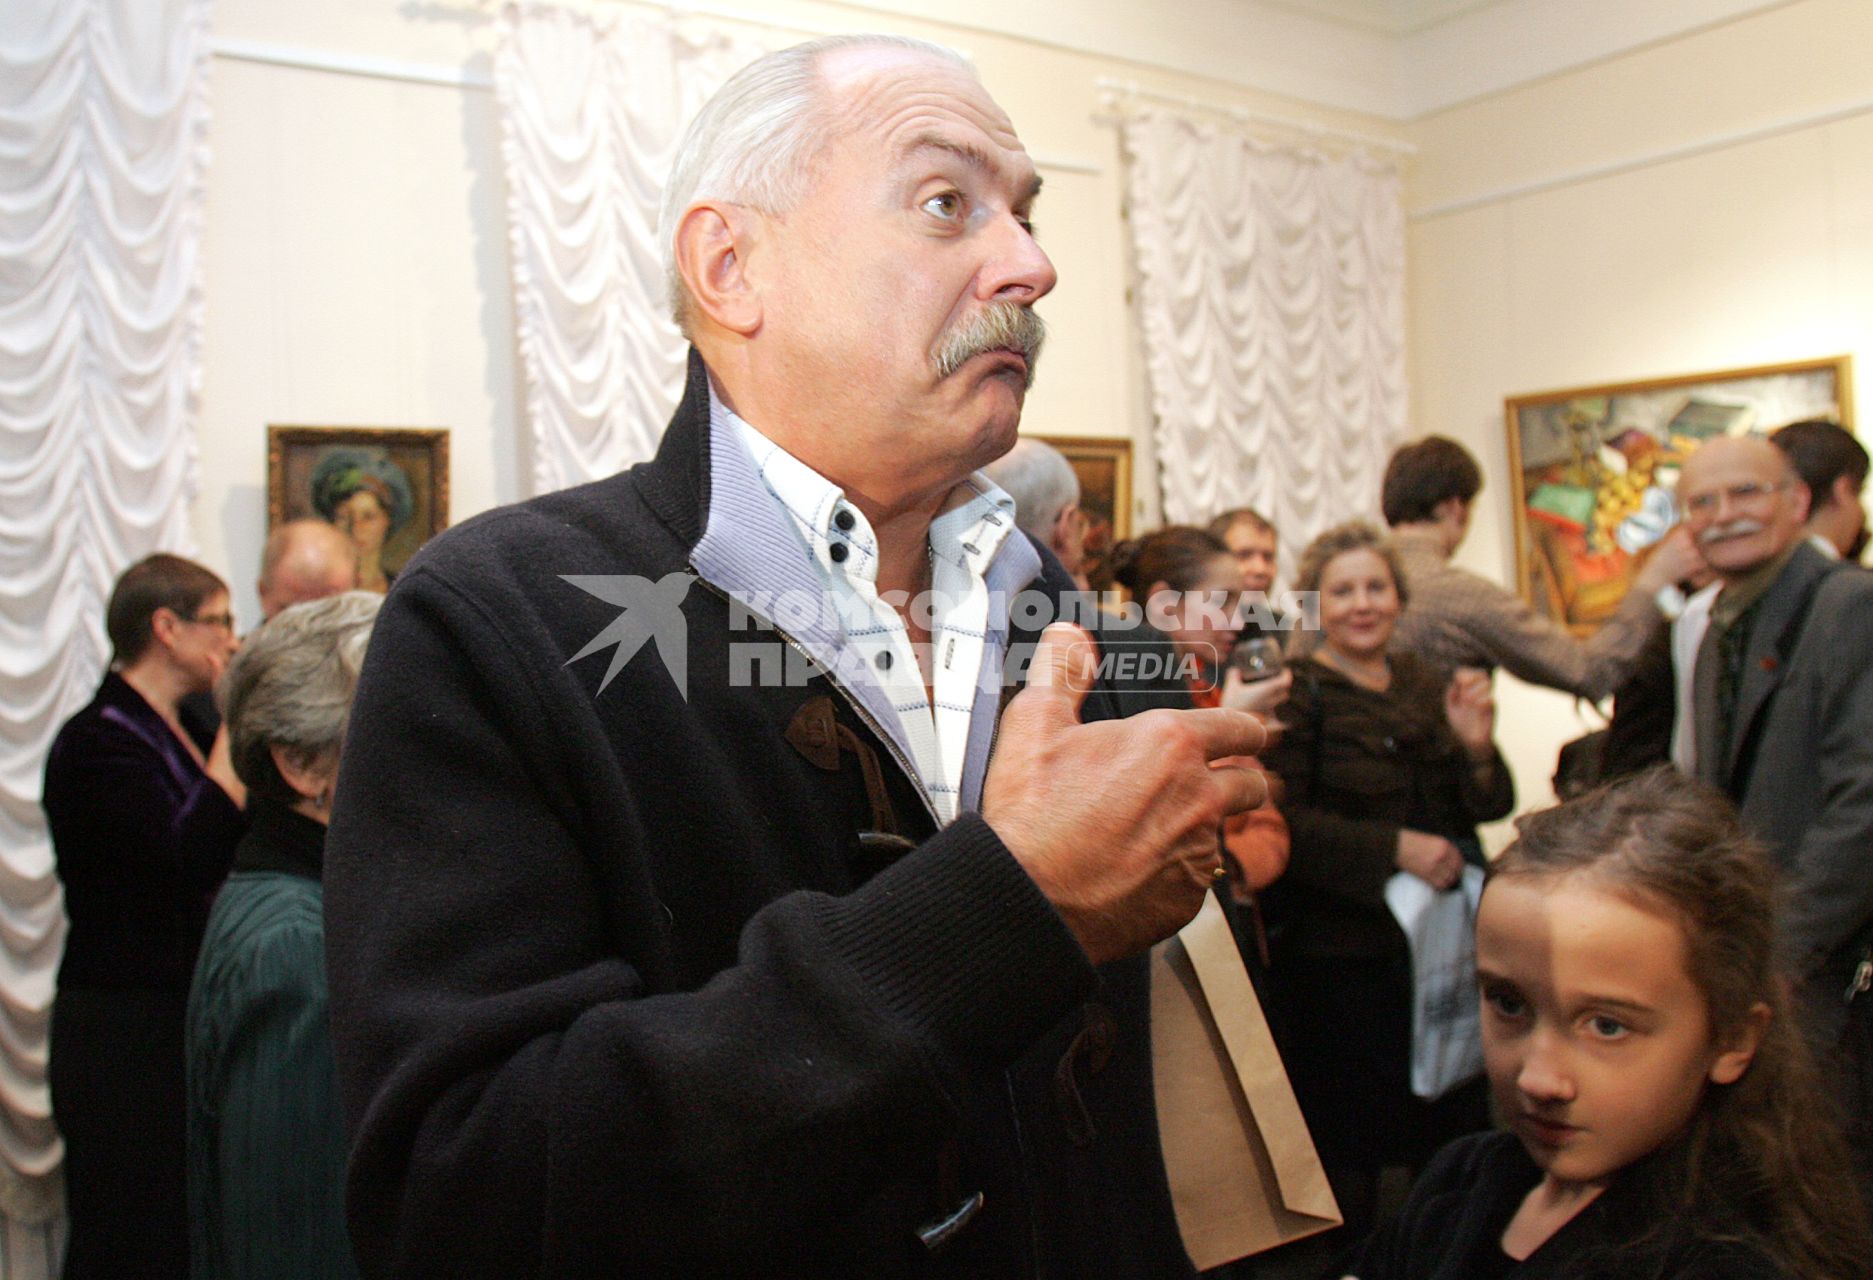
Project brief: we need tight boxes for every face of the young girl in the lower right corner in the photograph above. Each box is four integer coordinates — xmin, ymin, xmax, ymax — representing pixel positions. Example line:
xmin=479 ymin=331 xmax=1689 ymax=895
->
xmin=1476 ymin=875 xmax=1757 ymax=1184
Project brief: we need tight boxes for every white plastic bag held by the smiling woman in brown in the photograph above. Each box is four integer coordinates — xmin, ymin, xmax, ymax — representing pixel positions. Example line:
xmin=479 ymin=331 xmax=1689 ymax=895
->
xmin=1386 ymin=866 xmax=1483 ymax=1100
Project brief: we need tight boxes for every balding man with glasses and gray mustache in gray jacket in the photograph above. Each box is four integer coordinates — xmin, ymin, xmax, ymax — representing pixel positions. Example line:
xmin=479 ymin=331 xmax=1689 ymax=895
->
xmin=1678 ymin=437 xmax=1873 ymax=1184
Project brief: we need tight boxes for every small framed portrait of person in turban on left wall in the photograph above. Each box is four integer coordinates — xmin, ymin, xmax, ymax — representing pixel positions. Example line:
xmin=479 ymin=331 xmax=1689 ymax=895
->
xmin=266 ymin=425 xmax=450 ymax=592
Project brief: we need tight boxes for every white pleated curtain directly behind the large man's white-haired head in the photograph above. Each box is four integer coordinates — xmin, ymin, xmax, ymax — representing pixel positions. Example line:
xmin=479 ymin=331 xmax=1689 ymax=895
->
xmin=494 ymin=4 xmax=766 ymax=493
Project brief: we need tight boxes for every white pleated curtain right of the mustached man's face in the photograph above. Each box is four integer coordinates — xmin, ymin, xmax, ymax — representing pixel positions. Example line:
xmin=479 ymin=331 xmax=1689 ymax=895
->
xmin=1120 ymin=103 xmax=1407 ymax=579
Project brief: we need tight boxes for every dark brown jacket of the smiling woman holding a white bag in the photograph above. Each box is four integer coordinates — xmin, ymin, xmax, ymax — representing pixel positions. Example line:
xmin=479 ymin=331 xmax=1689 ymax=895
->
xmin=1262 ymin=654 xmax=1515 ymax=958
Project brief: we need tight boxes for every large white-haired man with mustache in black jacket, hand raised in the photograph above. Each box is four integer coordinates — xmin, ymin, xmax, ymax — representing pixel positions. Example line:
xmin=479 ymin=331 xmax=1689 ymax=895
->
xmin=326 ymin=37 xmax=1262 ymax=1280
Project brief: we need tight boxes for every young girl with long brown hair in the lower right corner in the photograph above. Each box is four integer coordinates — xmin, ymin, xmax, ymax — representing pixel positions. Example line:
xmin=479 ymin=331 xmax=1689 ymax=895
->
xmin=1350 ymin=770 xmax=1873 ymax=1280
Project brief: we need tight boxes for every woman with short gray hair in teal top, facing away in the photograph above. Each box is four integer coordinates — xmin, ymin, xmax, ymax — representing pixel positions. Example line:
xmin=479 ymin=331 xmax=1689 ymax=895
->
xmin=187 ymin=590 xmax=378 ymax=1278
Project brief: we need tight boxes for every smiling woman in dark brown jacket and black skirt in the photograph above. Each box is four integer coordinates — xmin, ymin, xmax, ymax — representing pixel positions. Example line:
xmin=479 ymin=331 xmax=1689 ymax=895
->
xmin=1262 ymin=523 xmax=1515 ymax=1237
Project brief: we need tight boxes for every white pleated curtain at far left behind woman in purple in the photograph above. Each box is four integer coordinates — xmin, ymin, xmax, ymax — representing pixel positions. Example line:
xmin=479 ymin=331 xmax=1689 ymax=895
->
xmin=0 ymin=0 xmax=210 ymax=1278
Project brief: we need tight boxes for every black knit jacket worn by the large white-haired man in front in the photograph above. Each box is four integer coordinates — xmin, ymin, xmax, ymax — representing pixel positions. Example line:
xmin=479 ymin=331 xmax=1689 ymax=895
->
xmin=326 ymin=356 xmax=1189 ymax=1278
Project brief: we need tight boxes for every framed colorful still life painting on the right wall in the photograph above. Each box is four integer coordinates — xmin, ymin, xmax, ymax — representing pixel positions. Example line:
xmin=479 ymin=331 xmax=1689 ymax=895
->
xmin=1504 ymin=356 xmax=1852 ymax=637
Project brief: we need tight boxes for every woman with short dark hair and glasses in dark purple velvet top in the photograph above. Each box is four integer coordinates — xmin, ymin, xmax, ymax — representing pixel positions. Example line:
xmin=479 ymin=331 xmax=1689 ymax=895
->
xmin=43 ymin=555 xmax=245 ymax=1278
